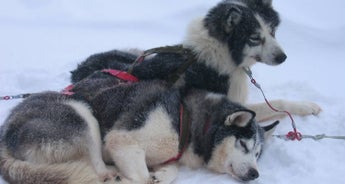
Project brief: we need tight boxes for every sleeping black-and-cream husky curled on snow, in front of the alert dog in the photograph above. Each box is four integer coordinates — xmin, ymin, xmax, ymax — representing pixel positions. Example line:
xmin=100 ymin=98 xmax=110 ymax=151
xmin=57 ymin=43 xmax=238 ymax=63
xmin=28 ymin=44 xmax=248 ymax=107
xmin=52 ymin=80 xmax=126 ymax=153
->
xmin=0 ymin=80 xmax=278 ymax=184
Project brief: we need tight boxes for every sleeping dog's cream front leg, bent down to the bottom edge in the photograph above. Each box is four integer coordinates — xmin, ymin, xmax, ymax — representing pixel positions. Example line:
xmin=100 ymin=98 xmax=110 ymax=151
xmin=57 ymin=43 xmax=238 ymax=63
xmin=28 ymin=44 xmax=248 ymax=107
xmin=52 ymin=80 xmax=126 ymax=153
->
xmin=105 ymin=130 xmax=150 ymax=183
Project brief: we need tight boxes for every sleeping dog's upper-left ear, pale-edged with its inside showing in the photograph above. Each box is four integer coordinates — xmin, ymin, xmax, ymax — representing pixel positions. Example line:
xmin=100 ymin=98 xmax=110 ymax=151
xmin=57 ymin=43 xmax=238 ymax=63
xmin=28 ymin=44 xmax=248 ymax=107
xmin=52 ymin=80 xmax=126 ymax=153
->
xmin=225 ymin=111 xmax=255 ymax=127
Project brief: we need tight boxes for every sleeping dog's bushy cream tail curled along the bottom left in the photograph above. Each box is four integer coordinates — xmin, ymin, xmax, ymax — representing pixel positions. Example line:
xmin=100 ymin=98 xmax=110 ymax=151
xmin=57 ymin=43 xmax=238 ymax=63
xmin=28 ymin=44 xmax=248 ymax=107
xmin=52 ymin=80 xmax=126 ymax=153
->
xmin=0 ymin=150 xmax=100 ymax=184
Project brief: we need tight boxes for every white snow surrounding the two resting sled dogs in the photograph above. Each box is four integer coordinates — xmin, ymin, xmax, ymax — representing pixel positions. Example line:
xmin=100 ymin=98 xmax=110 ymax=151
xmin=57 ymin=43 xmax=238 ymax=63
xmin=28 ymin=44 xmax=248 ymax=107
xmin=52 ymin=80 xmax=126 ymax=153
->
xmin=0 ymin=0 xmax=345 ymax=184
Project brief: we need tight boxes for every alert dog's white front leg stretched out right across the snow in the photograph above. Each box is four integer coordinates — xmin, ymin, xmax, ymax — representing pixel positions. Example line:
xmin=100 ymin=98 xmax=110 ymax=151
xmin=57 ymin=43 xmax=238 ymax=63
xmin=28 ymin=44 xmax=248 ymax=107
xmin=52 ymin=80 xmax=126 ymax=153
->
xmin=247 ymin=100 xmax=322 ymax=122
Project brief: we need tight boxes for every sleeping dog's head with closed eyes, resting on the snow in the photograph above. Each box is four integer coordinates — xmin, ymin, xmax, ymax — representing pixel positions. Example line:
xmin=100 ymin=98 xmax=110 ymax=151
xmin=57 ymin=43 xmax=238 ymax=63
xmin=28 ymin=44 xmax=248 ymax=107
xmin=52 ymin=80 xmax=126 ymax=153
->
xmin=207 ymin=110 xmax=279 ymax=181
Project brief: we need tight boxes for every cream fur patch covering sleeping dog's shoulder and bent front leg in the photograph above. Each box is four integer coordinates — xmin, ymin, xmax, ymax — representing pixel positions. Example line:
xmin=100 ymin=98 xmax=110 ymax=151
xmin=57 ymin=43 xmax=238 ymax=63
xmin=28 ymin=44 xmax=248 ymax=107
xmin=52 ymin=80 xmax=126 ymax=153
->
xmin=105 ymin=107 xmax=179 ymax=183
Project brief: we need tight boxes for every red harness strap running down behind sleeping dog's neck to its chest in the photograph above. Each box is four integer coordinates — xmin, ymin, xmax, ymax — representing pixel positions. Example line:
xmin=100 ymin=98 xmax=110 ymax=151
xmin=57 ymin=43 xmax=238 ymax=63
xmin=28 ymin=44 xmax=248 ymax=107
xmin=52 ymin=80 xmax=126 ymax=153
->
xmin=161 ymin=104 xmax=190 ymax=165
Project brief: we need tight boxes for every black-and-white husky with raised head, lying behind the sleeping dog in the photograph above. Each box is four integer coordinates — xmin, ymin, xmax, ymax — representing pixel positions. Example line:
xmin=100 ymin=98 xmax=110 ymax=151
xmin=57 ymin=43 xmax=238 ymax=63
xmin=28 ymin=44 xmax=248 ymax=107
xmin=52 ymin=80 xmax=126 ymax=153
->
xmin=72 ymin=0 xmax=321 ymax=122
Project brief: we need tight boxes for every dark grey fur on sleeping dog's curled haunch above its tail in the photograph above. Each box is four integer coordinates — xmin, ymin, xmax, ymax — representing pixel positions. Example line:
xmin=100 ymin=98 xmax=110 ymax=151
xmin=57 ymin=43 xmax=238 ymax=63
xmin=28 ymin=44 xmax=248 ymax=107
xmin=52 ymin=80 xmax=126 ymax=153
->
xmin=1 ymin=92 xmax=87 ymax=159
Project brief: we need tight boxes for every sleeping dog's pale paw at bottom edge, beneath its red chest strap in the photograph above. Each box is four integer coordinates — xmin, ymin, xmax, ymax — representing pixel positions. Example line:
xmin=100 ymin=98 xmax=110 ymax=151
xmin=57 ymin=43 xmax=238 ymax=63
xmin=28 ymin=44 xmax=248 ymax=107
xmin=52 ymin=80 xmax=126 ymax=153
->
xmin=151 ymin=164 xmax=178 ymax=184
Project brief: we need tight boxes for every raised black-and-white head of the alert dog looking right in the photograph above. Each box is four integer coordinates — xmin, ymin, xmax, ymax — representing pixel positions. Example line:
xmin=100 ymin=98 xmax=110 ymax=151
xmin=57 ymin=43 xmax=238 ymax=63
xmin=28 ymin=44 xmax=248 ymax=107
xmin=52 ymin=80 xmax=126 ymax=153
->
xmin=204 ymin=0 xmax=287 ymax=66
